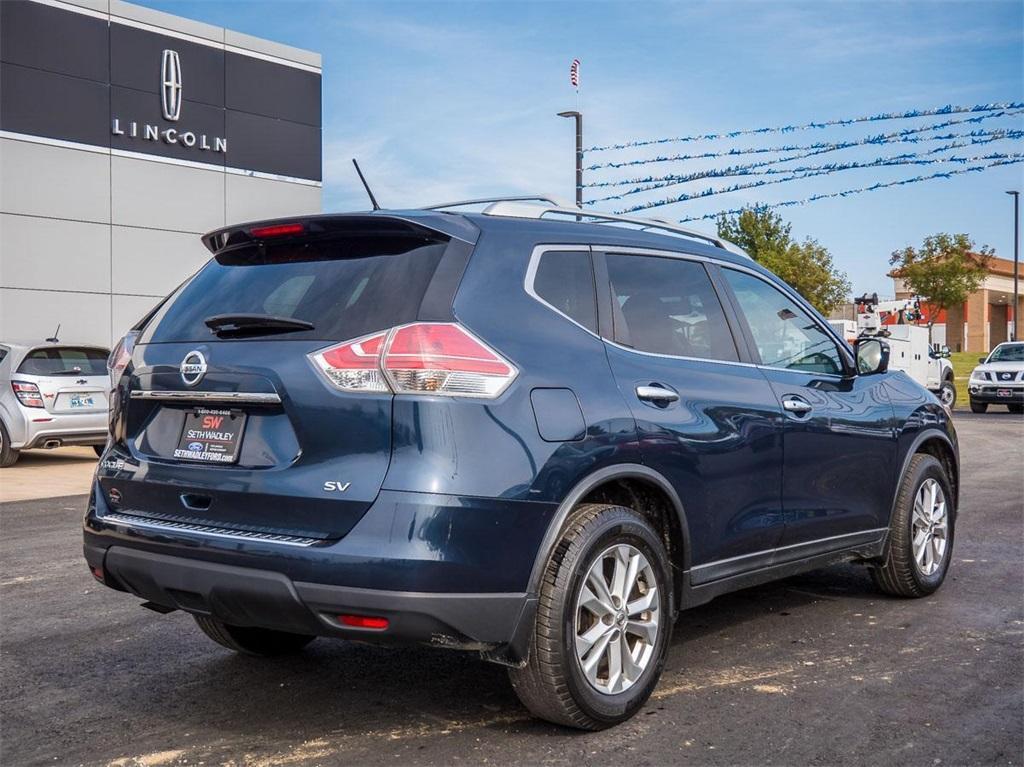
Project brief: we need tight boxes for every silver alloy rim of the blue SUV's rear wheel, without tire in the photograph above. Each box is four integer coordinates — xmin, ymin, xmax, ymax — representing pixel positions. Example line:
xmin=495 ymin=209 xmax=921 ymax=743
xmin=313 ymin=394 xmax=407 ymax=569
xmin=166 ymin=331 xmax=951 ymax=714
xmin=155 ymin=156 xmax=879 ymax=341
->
xmin=573 ymin=544 xmax=662 ymax=694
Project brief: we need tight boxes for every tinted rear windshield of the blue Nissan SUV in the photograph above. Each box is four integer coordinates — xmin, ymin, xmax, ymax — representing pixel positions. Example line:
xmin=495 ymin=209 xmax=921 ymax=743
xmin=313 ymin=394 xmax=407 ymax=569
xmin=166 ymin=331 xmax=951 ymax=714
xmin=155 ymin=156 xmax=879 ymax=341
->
xmin=140 ymin=235 xmax=447 ymax=343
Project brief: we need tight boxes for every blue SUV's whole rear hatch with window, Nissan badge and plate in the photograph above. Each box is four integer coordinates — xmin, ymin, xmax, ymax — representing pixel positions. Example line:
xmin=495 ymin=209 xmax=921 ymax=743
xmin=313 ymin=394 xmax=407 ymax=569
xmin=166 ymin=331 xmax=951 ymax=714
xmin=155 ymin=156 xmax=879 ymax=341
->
xmin=101 ymin=216 xmax=470 ymax=539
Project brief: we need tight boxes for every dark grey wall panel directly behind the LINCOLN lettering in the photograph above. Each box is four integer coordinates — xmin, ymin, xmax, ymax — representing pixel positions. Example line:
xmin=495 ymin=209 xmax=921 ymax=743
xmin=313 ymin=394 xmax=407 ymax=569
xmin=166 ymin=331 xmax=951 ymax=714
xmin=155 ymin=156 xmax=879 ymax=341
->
xmin=111 ymin=86 xmax=230 ymax=166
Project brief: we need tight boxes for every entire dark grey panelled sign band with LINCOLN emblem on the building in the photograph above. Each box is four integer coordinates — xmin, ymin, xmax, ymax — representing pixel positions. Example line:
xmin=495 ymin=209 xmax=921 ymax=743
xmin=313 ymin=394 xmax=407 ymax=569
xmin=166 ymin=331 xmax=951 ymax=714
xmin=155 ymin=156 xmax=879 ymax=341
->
xmin=0 ymin=0 xmax=322 ymax=180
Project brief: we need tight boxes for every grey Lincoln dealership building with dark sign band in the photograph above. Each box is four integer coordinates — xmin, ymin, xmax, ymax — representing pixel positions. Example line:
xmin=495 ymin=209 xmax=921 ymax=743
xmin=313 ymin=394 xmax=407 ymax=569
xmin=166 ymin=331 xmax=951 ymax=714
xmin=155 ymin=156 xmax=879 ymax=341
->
xmin=0 ymin=0 xmax=322 ymax=344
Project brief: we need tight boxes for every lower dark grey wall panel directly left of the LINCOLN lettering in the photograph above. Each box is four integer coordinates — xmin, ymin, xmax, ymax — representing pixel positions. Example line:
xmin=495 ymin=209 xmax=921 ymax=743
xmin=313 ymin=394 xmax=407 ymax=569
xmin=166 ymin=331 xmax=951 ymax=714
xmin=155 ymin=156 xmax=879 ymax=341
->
xmin=0 ymin=63 xmax=111 ymax=146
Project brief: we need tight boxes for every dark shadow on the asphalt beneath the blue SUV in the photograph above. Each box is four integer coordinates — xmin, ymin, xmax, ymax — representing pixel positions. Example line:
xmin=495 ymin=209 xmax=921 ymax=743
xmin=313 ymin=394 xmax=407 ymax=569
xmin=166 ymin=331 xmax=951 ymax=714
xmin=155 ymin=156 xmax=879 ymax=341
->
xmin=105 ymin=567 xmax=880 ymax=743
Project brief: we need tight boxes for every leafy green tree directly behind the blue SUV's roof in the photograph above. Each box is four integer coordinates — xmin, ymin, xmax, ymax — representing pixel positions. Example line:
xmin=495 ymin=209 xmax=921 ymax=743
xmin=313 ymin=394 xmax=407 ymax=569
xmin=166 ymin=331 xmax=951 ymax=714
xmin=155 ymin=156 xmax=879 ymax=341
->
xmin=718 ymin=206 xmax=850 ymax=316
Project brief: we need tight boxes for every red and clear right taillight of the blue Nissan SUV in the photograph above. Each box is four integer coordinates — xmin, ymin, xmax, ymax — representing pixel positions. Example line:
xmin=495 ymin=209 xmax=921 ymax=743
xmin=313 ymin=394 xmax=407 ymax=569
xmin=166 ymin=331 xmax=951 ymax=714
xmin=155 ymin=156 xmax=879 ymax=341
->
xmin=309 ymin=323 xmax=518 ymax=398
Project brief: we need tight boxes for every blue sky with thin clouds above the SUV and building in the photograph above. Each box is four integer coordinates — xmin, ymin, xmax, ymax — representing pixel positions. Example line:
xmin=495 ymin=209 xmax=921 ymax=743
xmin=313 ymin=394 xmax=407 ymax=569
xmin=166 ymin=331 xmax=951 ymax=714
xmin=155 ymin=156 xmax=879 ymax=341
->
xmin=141 ymin=0 xmax=1024 ymax=294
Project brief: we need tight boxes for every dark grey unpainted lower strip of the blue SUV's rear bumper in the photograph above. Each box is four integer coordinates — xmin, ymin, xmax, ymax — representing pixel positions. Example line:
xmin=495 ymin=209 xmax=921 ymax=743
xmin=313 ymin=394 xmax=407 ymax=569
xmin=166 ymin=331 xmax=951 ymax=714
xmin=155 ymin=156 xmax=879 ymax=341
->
xmin=85 ymin=544 xmax=536 ymax=651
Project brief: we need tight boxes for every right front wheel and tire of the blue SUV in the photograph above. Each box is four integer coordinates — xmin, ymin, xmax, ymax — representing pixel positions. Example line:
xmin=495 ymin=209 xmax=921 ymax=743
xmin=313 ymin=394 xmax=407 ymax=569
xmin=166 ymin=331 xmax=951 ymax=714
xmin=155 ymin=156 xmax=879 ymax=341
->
xmin=872 ymin=453 xmax=956 ymax=597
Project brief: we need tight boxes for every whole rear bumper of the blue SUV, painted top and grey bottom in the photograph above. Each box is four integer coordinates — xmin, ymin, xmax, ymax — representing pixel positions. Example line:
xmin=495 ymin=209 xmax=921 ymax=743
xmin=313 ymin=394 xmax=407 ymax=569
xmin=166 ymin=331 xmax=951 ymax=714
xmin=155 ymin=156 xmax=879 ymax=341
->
xmin=84 ymin=485 xmax=555 ymax=663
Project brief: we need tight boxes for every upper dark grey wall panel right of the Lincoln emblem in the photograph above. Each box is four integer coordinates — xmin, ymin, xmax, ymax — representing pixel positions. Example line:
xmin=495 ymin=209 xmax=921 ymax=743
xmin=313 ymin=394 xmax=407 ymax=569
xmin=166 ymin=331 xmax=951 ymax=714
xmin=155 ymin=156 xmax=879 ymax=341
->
xmin=224 ymin=53 xmax=321 ymax=128
